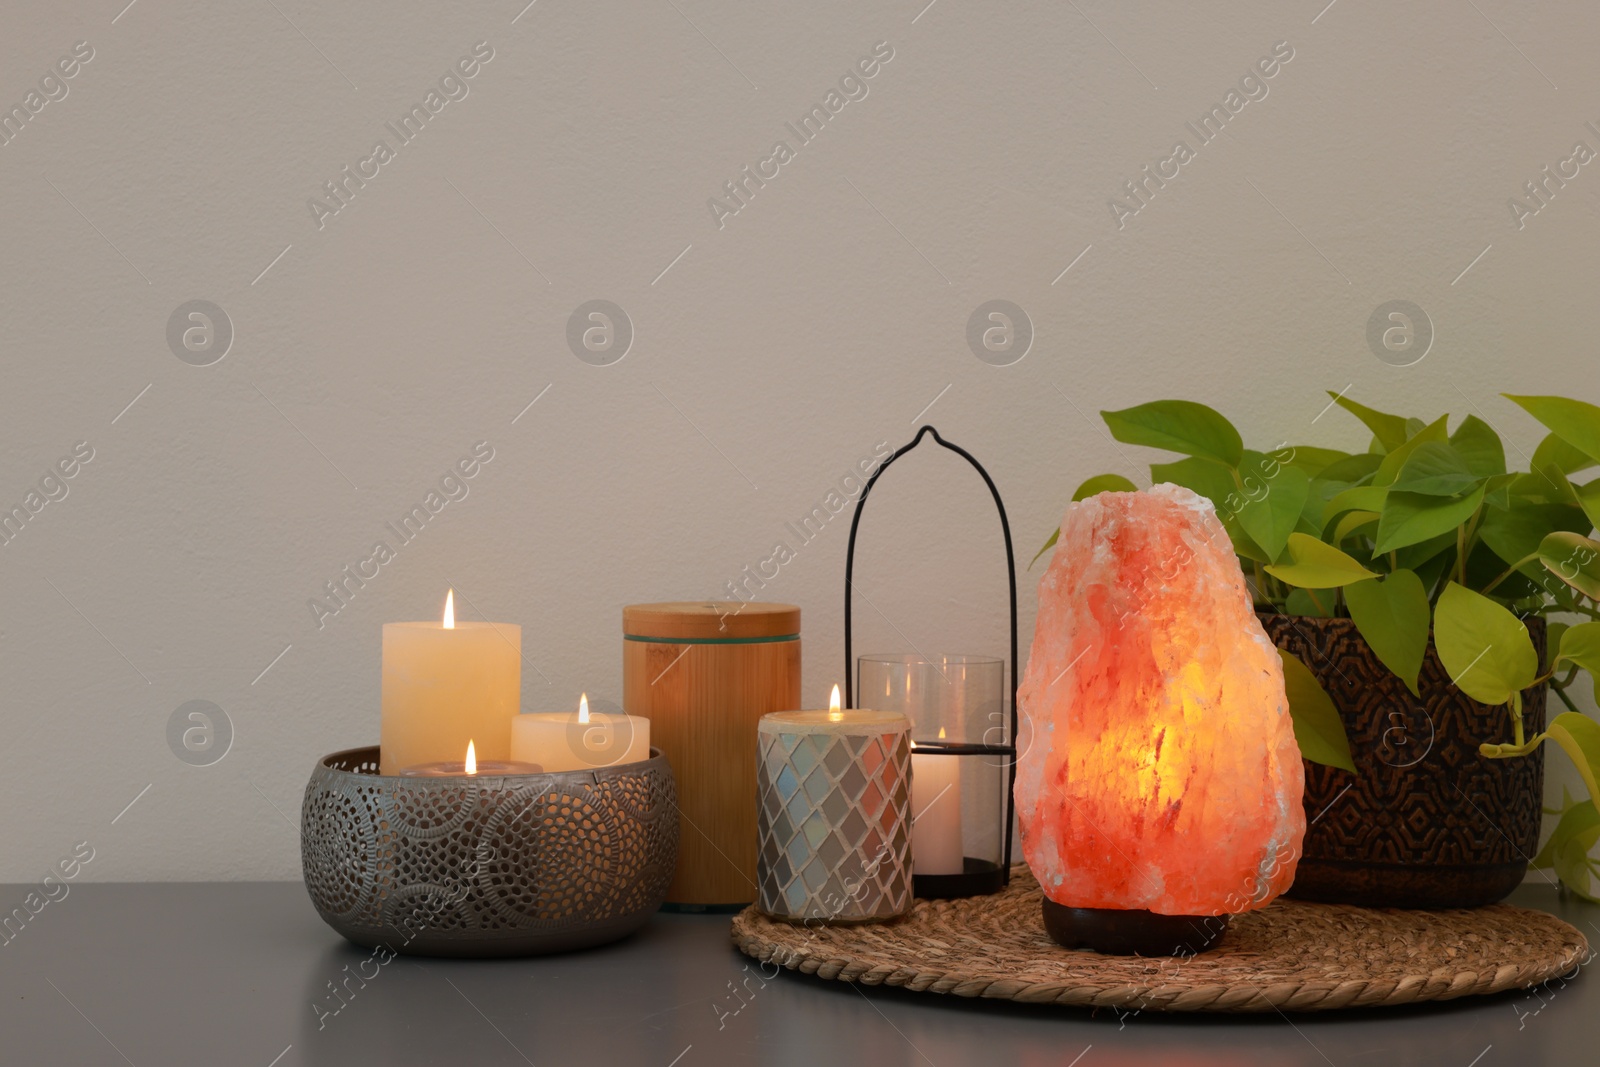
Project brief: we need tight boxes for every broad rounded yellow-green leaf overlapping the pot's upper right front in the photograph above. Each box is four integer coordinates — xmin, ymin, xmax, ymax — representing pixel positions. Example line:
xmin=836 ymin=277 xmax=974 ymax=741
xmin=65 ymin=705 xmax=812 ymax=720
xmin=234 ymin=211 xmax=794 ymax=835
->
xmin=1434 ymin=582 xmax=1536 ymax=703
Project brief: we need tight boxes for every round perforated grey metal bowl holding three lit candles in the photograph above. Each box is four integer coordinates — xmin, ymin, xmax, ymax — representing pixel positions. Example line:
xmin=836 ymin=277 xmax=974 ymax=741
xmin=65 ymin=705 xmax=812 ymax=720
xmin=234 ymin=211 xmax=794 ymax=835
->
xmin=301 ymin=747 xmax=678 ymax=957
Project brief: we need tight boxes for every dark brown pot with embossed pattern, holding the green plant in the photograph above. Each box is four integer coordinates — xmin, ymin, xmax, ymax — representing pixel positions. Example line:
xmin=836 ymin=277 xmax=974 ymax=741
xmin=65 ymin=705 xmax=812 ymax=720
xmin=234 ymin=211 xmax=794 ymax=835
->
xmin=1261 ymin=614 xmax=1546 ymax=907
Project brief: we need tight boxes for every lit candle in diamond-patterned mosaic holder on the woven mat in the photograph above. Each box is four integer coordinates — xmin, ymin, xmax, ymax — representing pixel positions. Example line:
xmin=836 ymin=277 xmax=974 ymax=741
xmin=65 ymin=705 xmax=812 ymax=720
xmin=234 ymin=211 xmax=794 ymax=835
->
xmin=755 ymin=685 xmax=912 ymax=923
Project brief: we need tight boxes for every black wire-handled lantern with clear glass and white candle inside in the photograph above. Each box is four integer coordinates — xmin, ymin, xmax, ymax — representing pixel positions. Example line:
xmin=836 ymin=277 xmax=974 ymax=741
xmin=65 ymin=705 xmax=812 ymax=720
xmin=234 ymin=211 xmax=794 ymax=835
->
xmin=845 ymin=426 xmax=1018 ymax=897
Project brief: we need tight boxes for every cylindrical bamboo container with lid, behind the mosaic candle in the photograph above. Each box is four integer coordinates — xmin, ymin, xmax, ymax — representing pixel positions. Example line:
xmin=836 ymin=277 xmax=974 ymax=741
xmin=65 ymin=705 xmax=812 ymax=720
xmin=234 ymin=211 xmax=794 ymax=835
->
xmin=622 ymin=601 xmax=800 ymax=909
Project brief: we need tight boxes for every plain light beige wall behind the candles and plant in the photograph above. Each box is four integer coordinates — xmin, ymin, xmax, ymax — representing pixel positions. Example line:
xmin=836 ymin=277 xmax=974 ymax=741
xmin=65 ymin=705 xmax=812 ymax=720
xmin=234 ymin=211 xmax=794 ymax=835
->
xmin=0 ymin=0 xmax=1600 ymax=880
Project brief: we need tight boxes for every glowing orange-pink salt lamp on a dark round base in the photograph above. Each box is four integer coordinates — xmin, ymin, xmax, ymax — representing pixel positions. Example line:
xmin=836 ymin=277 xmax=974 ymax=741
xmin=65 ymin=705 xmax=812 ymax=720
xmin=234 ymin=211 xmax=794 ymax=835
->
xmin=1016 ymin=485 xmax=1306 ymax=955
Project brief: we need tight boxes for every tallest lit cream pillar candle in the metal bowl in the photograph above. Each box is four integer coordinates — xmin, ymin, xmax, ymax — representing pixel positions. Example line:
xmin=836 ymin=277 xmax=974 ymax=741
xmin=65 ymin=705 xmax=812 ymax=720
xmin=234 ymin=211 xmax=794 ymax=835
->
xmin=378 ymin=592 xmax=522 ymax=774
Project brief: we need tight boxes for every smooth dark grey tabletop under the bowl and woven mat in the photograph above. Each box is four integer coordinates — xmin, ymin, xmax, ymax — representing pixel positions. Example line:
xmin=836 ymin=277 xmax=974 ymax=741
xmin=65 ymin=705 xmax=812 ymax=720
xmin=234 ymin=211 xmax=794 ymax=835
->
xmin=0 ymin=883 xmax=1600 ymax=1067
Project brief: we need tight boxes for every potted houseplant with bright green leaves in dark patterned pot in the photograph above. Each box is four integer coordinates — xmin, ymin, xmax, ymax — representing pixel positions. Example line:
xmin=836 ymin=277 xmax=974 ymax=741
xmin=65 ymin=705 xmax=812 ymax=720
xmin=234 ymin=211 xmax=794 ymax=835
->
xmin=1035 ymin=394 xmax=1600 ymax=905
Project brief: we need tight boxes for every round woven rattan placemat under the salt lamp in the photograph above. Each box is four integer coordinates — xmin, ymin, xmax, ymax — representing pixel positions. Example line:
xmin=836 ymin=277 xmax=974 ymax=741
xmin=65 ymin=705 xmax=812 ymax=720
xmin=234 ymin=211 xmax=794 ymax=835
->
xmin=733 ymin=864 xmax=1589 ymax=1011
